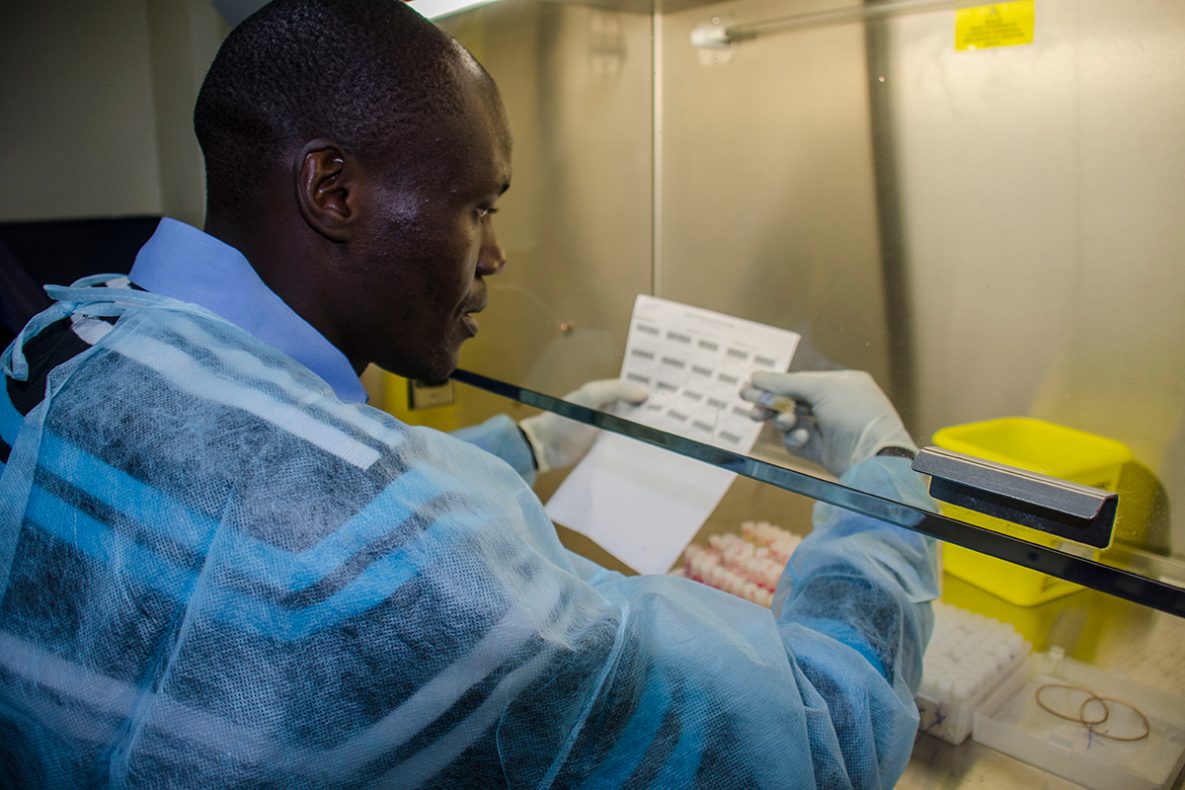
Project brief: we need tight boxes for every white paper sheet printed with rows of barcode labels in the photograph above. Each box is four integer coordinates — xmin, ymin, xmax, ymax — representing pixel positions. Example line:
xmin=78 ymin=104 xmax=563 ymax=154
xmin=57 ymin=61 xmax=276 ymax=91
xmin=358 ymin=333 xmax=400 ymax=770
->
xmin=546 ymin=295 xmax=800 ymax=573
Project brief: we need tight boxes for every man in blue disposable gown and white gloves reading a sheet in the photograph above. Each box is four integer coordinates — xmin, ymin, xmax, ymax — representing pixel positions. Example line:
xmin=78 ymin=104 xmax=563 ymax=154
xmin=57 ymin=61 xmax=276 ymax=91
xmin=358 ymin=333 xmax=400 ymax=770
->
xmin=0 ymin=0 xmax=934 ymax=788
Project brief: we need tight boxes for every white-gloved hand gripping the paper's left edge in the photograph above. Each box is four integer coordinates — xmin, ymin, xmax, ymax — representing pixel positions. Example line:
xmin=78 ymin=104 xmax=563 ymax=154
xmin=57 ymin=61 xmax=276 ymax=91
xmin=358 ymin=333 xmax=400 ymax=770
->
xmin=519 ymin=379 xmax=649 ymax=473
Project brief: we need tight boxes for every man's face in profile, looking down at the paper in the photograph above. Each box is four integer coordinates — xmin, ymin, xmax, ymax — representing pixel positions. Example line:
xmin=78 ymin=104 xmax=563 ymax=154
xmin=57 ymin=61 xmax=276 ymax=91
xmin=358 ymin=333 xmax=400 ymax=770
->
xmin=350 ymin=84 xmax=511 ymax=381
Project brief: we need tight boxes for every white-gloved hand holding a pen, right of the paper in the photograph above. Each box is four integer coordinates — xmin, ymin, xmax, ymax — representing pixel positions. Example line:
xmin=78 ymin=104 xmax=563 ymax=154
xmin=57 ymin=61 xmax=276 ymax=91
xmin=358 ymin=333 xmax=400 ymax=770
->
xmin=741 ymin=371 xmax=917 ymax=476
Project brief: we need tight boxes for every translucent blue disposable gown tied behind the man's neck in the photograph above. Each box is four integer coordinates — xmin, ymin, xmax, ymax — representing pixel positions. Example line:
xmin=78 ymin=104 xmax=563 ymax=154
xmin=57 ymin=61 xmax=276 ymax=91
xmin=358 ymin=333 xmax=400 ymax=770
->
xmin=0 ymin=280 xmax=935 ymax=788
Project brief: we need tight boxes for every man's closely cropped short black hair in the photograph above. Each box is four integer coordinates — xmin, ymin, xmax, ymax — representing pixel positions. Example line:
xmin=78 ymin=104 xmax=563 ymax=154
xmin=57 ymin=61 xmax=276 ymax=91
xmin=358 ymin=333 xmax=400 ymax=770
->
xmin=193 ymin=0 xmax=460 ymax=208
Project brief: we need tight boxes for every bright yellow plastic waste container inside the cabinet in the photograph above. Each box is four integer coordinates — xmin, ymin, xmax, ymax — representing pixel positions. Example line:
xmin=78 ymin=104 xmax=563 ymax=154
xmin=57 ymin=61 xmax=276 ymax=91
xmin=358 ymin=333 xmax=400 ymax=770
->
xmin=934 ymin=417 xmax=1132 ymax=606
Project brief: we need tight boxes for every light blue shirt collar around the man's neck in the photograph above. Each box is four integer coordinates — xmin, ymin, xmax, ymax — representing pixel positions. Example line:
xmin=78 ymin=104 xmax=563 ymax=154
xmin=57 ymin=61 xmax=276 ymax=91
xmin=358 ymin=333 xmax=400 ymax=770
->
xmin=128 ymin=218 xmax=366 ymax=403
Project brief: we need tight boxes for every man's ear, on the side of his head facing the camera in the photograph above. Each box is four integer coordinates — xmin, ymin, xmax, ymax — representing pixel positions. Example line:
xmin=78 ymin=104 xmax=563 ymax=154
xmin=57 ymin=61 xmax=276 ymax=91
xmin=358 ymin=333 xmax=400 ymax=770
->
xmin=295 ymin=140 xmax=361 ymax=242
